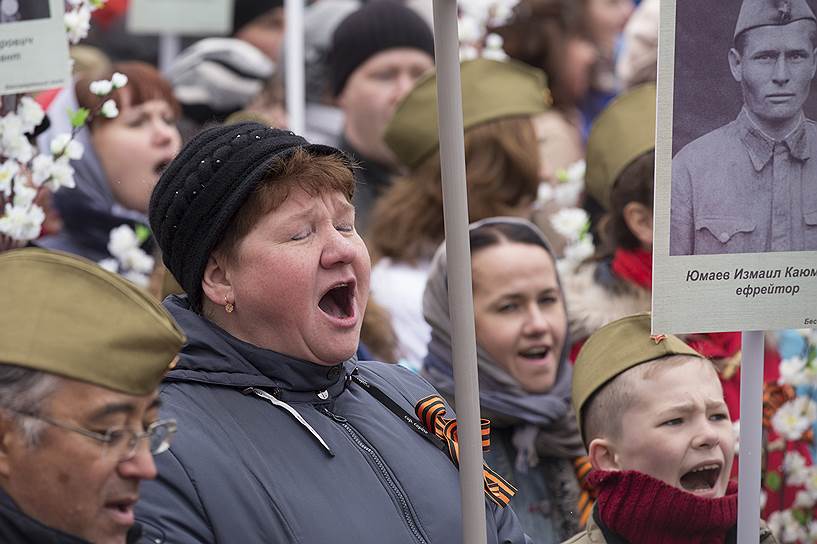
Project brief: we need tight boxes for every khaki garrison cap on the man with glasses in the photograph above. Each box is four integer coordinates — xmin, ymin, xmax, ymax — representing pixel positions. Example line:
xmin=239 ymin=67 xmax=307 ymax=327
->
xmin=0 ymin=249 xmax=185 ymax=395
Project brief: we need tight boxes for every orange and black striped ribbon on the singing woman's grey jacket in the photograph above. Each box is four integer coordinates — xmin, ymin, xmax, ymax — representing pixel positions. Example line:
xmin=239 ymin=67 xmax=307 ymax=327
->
xmin=414 ymin=395 xmax=516 ymax=508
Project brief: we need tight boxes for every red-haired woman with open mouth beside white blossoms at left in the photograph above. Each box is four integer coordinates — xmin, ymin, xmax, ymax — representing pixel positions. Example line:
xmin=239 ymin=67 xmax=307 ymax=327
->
xmin=37 ymin=62 xmax=181 ymax=261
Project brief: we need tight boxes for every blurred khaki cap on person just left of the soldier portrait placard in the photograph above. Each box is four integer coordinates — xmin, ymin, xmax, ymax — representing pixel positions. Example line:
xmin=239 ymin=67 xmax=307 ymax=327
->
xmin=584 ymin=83 xmax=655 ymax=210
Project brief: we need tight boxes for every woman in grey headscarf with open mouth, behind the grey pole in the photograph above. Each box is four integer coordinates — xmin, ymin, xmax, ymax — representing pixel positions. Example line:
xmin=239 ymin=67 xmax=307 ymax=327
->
xmin=423 ymin=218 xmax=590 ymax=544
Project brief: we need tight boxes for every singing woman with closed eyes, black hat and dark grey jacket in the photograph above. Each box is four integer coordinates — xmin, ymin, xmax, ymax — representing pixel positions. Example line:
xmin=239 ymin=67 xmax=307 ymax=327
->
xmin=137 ymin=123 xmax=528 ymax=544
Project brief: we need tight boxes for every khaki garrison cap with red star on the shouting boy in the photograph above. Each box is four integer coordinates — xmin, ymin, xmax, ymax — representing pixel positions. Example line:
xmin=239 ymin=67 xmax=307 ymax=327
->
xmin=572 ymin=312 xmax=704 ymax=439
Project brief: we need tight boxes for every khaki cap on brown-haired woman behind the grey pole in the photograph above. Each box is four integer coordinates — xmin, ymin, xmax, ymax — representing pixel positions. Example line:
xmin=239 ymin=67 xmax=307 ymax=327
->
xmin=384 ymin=58 xmax=551 ymax=170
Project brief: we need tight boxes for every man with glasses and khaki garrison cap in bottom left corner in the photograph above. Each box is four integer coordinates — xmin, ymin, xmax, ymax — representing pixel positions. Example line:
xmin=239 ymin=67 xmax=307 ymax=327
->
xmin=0 ymin=249 xmax=184 ymax=544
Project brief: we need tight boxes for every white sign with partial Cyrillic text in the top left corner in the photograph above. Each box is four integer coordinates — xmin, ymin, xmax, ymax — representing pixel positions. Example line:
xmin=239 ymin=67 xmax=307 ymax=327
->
xmin=0 ymin=0 xmax=71 ymax=95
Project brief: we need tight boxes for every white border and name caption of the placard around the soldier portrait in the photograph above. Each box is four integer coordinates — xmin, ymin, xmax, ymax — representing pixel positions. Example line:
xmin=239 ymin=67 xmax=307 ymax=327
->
xmin=652 ymin=0 xmax=817 ymax=334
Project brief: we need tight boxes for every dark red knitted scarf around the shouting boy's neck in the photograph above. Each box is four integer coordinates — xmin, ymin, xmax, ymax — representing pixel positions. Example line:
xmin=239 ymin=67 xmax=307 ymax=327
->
xmin=588 ymin=470 xmax=738 ymax=544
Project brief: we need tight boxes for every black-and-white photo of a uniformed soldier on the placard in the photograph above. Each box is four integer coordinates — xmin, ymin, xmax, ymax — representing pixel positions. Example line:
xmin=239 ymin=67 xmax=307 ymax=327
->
xmin=669 ymin=0 xmax=817 ymax=255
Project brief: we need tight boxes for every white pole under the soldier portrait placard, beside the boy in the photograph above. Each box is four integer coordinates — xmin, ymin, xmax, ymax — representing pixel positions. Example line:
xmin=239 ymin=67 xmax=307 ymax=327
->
xmin=738 ymin=331 xmax=763 ymax=542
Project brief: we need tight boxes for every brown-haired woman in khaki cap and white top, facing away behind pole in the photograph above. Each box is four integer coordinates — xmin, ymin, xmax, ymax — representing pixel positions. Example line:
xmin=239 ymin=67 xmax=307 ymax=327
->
xmin=367 ymin=59 xmax=547 ymax=370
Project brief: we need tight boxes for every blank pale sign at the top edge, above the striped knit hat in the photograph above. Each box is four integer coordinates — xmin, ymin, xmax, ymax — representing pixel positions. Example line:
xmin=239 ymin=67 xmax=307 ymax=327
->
xmin=127 ymin=0 xmax=233 ymax=36
